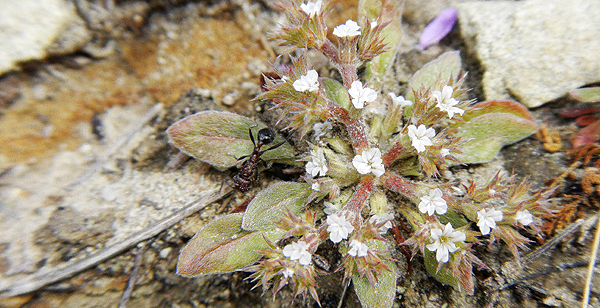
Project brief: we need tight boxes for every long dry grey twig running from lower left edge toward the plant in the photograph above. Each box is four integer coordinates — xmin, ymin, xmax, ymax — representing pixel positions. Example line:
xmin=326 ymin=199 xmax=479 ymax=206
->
xmin=0 ymin=188 xmax=232 ymax=297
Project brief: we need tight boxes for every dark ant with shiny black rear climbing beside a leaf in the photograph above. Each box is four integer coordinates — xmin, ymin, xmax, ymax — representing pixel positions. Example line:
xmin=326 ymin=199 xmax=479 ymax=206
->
xmin=233 ymin=125 xmax=285 ymax=192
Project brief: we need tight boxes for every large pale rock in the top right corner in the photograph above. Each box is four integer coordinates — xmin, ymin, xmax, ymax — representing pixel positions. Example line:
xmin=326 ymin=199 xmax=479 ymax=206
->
xmin=456 ymin=0 xmax=600 ymax=107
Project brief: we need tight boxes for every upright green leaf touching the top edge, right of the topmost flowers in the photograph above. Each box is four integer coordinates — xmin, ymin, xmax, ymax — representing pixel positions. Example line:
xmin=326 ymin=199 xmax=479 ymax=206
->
xmin=358 ymin=0 xmax=403 ymax=87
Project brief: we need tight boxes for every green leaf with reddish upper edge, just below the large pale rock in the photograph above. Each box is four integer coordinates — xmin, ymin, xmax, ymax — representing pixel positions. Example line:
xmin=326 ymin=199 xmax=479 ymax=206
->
xmin=455 ymin=106 xmax=538 ymax=163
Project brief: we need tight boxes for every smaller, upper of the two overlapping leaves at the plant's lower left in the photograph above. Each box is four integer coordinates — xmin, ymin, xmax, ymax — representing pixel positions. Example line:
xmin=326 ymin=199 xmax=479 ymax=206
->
xmin=242 ymin=182 xmax=312 ymax=231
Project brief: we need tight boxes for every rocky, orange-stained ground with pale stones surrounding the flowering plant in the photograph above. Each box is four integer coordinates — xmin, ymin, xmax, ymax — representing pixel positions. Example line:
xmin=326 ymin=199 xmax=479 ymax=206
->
xmin=0 ymin=0 xmax=600 ymax=307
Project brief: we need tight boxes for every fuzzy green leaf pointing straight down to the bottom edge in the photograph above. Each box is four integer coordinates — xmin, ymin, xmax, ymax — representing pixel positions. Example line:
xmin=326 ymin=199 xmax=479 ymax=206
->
xmin=352 ymin=241 xmax=396 ymax=308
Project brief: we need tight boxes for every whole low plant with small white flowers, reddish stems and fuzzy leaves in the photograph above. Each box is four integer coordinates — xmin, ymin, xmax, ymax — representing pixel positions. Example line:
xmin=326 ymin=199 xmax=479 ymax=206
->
xmin=167 ymin=0 xmax=550 ymax=307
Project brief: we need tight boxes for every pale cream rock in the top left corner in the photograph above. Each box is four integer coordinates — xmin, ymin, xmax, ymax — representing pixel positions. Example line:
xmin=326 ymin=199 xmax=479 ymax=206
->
xmin=0 ymin=0 xmax=90 ymax=74
